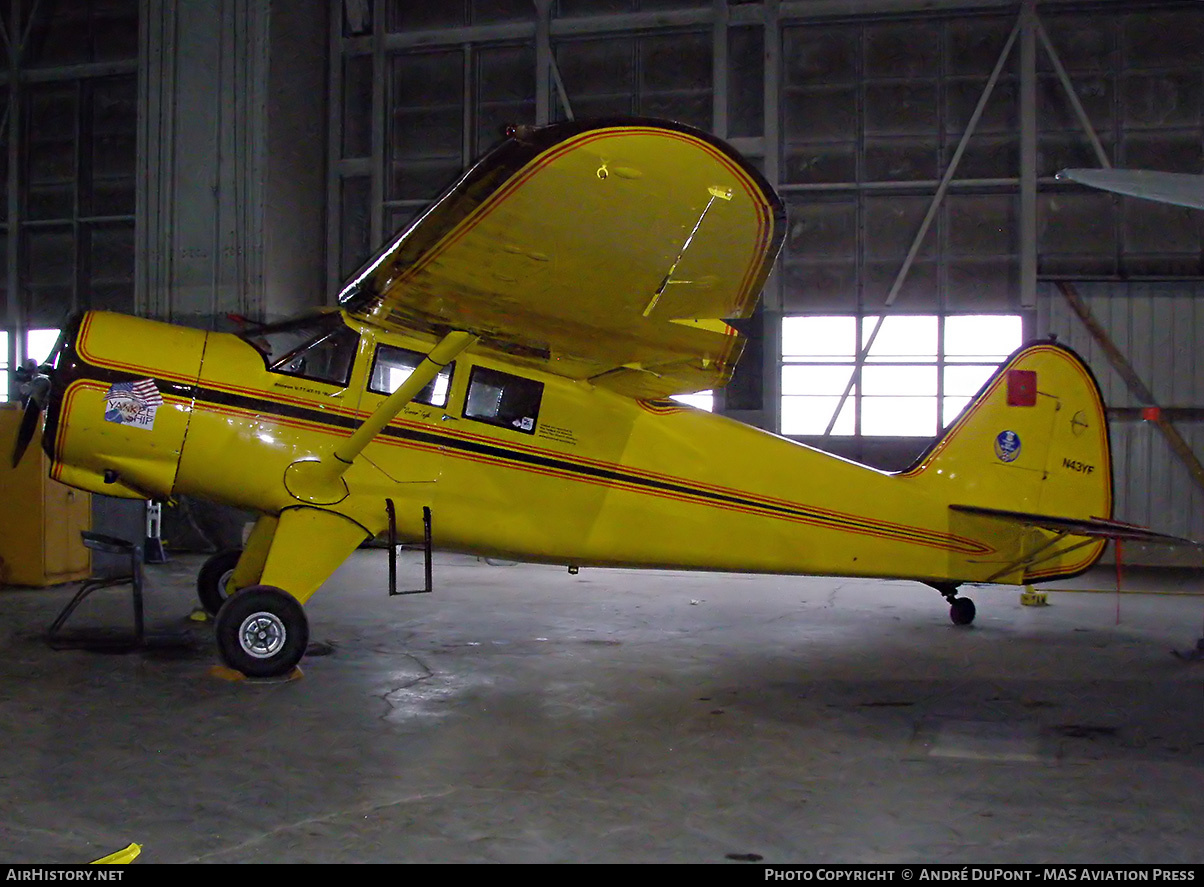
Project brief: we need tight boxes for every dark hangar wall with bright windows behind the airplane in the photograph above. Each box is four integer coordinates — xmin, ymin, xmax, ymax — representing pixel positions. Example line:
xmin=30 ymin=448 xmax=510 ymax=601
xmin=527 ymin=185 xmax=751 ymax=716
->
xmin=7 ymin=0 xmax=1204 ymax=553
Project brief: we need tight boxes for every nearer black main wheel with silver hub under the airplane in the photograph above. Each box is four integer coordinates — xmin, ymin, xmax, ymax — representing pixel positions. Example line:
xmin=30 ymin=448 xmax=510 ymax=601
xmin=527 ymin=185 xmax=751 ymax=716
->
xmin=214 ymin=585 xmax=309 ymax=678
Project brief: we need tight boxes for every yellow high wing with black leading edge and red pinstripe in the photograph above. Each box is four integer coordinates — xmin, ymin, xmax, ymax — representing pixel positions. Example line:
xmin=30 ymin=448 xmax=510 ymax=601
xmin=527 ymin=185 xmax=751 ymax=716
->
xmin=340 ymin=118 xmax=785 ymax=398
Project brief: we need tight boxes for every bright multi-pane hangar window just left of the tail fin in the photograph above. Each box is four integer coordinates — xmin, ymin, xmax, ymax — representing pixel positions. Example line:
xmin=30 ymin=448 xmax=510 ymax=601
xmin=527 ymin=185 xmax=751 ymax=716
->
xmin=781 ymin=314 xmax=1023 ymax=437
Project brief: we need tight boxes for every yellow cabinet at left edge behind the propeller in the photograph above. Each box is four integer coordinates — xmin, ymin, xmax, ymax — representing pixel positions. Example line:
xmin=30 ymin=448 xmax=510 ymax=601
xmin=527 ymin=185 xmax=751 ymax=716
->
xmin=0 ymin=403 xmax=92 ymax=585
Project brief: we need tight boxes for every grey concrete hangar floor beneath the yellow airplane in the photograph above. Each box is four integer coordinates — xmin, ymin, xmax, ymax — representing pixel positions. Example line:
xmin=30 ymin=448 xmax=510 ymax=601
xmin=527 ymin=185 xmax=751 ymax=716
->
xmin=0 ymin=551 xmax=1204 ymax=864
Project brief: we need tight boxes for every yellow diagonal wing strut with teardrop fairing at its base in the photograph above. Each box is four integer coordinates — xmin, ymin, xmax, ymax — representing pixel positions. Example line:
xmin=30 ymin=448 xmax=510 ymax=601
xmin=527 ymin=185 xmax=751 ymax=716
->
xmin=284 ymin=330 xmax=477 ymax=505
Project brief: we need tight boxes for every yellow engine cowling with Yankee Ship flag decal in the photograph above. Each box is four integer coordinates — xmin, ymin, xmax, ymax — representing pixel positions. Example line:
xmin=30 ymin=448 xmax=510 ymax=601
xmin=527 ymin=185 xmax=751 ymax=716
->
xmin=41 ymin=312 xmax=207 ymax=498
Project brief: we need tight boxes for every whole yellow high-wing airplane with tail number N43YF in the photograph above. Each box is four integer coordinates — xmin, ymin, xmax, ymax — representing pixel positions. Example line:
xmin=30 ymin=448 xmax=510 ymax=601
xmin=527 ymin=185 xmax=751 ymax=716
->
xmin=14 ymin=118 xmax=1184 ymax=676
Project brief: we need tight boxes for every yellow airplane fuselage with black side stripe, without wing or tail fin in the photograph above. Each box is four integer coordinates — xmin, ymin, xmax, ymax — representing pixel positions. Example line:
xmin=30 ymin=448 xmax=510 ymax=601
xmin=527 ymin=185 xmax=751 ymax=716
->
xmin=45 ymin=312 xmax=1110 ymax=581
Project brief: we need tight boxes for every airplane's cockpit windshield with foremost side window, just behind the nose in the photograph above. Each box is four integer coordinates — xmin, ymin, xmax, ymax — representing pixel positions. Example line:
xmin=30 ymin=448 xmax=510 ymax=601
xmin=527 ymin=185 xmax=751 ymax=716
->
xmin=242 ymin=314 xmax=360 ymax=385
